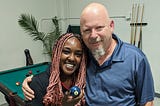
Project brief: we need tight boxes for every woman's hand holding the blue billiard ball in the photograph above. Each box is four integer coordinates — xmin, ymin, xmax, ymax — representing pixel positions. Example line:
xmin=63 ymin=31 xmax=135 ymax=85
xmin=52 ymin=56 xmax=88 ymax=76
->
xmin=62 ymin=90 xmax=84 ymax=106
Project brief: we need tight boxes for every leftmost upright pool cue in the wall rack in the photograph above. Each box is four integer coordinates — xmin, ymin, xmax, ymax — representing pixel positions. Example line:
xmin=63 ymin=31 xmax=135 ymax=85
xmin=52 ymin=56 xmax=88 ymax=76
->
xmin=130 ymin=4 xmax=135 ymax=44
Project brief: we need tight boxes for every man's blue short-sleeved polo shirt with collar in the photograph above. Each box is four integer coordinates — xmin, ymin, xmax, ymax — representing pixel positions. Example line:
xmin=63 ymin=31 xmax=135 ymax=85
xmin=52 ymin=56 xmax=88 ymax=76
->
xmin=85 ymin=34 xmax=154 ymax=106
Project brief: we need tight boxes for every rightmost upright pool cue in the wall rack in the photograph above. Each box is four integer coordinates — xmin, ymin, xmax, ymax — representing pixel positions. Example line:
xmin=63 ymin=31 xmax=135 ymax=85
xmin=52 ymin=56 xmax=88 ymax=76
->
xmin=138 ymin=4 xmax=144 ymax=49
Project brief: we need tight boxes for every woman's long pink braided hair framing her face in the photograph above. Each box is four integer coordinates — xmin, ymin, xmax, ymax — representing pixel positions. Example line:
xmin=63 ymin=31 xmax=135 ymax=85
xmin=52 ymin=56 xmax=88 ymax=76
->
xmin=43 ymin=33 xmax=86 ymax=106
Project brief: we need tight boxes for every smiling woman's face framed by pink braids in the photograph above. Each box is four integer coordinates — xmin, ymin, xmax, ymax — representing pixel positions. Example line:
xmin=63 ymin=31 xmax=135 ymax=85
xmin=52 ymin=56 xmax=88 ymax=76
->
xmin=60 ymin=37 xmax=82 ymax=75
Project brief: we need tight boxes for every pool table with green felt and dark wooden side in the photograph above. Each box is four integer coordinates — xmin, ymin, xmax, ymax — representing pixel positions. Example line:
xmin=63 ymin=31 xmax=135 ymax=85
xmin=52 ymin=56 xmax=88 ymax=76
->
xmin=0 ymin=62 xmax=50 ymax=106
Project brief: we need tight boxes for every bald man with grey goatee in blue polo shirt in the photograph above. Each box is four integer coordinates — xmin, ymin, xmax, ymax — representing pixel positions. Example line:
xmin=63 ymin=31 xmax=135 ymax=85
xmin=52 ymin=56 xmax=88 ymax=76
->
xmin=23 ymin=3 xmax=154 ymax=106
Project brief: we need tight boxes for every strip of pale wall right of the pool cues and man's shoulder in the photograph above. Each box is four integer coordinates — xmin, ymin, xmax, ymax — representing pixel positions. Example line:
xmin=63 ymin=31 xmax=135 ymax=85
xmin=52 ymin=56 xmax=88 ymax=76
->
xmin=143 ymin=0 xmax=160 ymax=93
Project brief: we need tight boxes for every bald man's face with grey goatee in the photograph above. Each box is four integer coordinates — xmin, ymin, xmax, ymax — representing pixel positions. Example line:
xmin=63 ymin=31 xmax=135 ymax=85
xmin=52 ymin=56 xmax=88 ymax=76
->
xmin=81 ymin=13 xmax=114 ymax=58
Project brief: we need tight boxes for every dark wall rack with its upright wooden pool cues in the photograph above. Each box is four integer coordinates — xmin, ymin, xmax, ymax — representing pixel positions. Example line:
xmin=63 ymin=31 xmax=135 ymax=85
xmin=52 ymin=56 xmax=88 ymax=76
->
xmin=130 ymin=4 xmax=147 ymax=50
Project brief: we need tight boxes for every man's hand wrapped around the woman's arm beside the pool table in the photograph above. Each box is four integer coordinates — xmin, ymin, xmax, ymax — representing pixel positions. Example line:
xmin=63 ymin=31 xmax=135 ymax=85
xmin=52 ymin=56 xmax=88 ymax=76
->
xmin=22 ymin=76 xmax=34 ymax=100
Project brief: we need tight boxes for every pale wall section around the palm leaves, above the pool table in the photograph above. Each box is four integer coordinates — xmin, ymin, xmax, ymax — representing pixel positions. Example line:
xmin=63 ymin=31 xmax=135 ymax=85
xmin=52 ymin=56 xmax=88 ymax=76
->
xmin=0 ymin=0 xmax=57 ymax=71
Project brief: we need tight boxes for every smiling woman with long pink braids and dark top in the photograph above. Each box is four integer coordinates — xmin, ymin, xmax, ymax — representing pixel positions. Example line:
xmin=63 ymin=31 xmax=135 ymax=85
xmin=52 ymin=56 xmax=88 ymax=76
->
xmin=27 ymin=33 xmax=86 ymax=106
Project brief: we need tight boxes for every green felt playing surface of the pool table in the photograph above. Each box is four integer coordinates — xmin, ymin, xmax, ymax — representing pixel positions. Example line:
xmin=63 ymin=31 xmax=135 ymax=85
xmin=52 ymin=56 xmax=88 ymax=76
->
xmin=0 ymin=62 xmax=49 ymax=99
